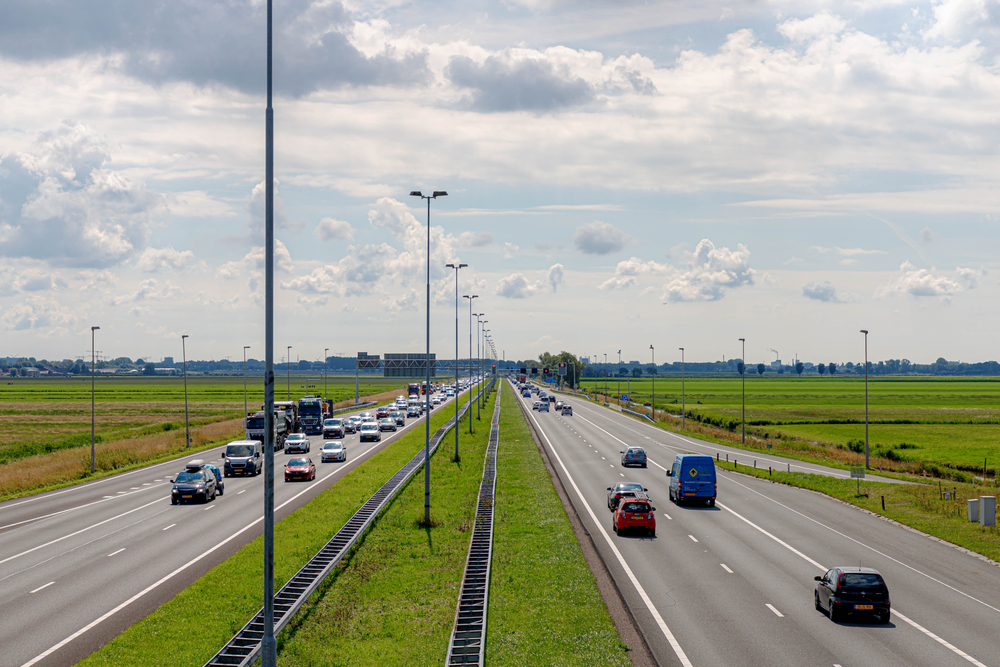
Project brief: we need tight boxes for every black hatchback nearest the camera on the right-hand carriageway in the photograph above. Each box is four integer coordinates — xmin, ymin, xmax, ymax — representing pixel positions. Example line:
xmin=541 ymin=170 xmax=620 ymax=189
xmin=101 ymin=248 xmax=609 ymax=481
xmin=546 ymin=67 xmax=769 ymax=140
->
xmin=813 ymin=567 xmax=890 ymax=623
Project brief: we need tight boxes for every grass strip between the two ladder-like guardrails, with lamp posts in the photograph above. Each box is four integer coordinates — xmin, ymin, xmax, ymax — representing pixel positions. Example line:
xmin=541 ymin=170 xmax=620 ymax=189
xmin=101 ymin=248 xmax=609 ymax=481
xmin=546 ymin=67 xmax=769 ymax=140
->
xmin=278 ymin=392 xmax=498 ymax=666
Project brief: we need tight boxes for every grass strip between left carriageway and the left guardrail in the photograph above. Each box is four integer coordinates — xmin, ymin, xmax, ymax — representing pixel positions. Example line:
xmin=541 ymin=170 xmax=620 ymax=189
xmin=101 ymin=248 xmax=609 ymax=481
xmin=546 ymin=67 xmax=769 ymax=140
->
xmin=79 ymin=388 xmax=475 ymax=667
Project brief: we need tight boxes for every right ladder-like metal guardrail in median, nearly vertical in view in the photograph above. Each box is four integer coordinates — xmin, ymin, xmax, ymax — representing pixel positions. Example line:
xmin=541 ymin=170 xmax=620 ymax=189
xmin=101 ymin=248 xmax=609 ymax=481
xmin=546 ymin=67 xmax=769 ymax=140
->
xmin=445 ymin=385 xmax=502 ymax=667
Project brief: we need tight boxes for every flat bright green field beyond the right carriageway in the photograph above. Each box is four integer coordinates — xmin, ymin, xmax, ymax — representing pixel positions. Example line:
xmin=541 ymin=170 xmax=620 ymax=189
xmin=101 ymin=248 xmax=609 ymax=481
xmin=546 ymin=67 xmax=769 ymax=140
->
xmin=583 ymin=374 xmax=1000 ymax=476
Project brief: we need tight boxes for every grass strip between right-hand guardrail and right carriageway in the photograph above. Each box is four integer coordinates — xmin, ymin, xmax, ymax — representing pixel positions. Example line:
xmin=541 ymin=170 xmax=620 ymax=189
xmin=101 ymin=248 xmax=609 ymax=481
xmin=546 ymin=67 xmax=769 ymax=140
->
xmin=486 ymin=387 xmax=631 ymax=667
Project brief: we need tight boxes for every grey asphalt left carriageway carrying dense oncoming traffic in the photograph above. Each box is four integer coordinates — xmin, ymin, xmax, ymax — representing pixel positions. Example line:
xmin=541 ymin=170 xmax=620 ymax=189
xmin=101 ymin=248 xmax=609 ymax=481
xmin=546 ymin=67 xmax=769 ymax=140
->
xmin=0 ymin=392 xmax=454 ymax=667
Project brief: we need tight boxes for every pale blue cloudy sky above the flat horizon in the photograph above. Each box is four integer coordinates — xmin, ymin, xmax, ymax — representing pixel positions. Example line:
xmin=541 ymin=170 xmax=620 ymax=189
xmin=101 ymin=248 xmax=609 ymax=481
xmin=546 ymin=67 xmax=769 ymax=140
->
xmin=0 ymin=0 xmax=1000 ymax=363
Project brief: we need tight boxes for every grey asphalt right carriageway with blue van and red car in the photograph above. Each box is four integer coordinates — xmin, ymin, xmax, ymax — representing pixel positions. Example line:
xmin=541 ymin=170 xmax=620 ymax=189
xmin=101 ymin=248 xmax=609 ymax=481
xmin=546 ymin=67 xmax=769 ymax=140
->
xmin=521 ymin=380 xmax=1000 ymax=667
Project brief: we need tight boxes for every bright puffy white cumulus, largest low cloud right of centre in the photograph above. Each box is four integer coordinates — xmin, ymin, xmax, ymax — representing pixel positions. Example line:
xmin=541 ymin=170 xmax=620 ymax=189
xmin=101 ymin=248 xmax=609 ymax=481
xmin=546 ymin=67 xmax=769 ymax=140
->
xmin=660 ymin=239 xmax=755 ymax=301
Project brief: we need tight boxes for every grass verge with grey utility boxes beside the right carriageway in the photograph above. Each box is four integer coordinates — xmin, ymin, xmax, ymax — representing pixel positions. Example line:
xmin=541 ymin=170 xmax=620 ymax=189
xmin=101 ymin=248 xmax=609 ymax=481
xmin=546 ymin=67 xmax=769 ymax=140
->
xmin=716 ymin=461 xmax=1000 ymax=561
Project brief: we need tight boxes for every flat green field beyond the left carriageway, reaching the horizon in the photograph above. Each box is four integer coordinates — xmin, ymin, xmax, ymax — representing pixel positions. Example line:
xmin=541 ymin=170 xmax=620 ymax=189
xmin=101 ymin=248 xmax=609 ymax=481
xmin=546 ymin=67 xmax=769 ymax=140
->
xmin=0 ymin=375 xmax=406 ymax=464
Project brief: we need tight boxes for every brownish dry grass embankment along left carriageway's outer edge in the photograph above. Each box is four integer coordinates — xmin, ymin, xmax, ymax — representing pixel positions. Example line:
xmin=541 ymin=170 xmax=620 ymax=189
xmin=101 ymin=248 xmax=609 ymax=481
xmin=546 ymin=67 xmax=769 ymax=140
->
xmin=0 ymin=389 xmax=399 ymax=500
